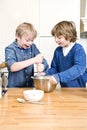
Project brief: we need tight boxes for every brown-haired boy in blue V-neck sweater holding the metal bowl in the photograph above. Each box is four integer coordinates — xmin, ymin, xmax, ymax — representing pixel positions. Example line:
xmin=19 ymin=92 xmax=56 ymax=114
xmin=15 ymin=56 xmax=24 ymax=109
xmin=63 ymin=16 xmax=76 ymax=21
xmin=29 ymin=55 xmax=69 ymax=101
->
xmin=46 ymin=21 xmax=87 ymax=87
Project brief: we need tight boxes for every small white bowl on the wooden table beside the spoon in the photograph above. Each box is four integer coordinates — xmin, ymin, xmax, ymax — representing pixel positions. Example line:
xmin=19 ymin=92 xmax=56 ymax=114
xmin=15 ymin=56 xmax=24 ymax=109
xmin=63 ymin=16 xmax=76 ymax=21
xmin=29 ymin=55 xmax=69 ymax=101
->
xmin=23 ymin=90 xmax=44 ymax=101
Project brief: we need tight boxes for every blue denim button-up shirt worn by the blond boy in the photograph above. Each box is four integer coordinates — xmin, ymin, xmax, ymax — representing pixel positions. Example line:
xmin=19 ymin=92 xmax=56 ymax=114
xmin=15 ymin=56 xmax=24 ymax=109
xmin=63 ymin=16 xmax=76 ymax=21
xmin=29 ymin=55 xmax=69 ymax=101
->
xmin=5 ymin=40 xmax=48 ymax=87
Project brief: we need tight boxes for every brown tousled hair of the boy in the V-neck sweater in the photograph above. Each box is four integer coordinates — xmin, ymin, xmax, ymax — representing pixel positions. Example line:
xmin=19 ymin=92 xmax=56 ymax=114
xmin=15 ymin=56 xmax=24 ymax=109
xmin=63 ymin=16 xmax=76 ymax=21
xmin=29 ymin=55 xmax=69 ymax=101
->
xmin=51 ymin=21 xmax=77 ymax=42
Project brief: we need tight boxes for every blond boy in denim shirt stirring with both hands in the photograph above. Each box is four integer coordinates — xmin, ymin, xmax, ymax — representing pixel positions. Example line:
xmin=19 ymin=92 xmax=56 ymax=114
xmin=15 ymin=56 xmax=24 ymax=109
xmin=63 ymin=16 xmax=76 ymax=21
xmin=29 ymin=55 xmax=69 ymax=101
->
xmin=5 ymin=23 xmax=48 ymax=87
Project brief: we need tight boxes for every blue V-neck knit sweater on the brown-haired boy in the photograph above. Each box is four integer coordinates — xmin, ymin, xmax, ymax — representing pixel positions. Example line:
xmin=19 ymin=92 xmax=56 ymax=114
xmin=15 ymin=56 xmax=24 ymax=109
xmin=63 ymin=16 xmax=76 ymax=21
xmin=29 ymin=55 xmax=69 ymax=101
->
xmin=47 ymin=43 xmax=87 ymax=87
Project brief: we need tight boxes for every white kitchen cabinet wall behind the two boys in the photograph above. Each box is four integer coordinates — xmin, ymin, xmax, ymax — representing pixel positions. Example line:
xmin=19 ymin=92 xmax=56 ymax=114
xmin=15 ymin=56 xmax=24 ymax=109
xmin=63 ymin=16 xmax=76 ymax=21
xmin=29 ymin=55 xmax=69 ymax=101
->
xmin=0 ymin=0 xmax=80 ymax=64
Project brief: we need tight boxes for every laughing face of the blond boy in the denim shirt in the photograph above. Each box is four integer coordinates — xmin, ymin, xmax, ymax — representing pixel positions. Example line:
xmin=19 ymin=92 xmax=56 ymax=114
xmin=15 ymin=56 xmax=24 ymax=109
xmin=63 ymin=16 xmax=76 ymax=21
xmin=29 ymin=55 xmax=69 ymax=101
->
xmin=17 ymin=35 xmax=33 ymax=49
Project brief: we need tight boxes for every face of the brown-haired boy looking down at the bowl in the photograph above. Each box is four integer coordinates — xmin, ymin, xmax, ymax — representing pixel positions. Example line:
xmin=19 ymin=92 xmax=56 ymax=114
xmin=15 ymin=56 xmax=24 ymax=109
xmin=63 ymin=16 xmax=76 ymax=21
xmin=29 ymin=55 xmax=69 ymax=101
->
xmin=55 ymin=35 xmax=70 ymax=47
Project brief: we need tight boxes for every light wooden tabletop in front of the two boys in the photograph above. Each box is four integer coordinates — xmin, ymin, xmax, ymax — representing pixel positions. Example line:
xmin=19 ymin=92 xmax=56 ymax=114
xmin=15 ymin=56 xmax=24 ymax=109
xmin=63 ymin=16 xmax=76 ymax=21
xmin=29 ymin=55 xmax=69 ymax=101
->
xmin=0 ymin=88 xmax=87 ymax=130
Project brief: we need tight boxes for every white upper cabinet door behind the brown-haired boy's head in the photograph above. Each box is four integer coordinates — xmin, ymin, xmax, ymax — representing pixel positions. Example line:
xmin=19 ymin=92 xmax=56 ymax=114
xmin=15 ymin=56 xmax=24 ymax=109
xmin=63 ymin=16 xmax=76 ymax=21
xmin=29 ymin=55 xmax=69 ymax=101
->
xmin=39 ymin=0 xmax=80 ymax=36
